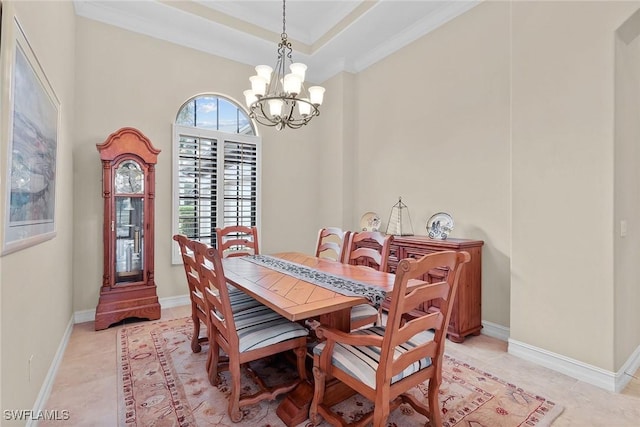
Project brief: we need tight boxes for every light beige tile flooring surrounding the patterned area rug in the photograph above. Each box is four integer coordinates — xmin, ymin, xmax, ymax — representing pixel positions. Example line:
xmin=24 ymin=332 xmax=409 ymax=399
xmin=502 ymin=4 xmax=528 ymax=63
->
xmin=39 ymin=306 xmax=640 ymax=427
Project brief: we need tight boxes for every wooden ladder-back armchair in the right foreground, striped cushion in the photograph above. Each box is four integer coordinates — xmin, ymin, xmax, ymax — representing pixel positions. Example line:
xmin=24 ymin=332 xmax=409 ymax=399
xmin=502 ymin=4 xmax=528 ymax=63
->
xmin=309 ymin=251 xmax=471 ymax=427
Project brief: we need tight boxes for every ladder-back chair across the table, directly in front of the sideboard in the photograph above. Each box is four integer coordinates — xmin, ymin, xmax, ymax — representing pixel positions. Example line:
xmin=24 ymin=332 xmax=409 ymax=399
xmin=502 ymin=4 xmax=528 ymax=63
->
xmin=344 ymin=231 xmax=393 ymax=329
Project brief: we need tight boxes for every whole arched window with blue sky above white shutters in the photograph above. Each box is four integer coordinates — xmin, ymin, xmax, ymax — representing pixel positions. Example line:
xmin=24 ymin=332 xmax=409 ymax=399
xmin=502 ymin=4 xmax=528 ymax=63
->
xmin=173 ymin=94 xmax=261 ymax=263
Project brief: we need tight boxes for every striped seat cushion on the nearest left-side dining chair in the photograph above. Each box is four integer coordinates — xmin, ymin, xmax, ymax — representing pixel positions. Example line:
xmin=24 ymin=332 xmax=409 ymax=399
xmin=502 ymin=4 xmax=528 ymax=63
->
xmin=233 ymin=305 xmax=309 ymax=352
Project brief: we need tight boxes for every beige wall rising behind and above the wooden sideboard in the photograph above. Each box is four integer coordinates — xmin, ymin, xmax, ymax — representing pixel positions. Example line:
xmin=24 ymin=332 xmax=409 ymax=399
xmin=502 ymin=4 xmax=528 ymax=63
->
xmin=350 ymin=2 xmax=511 ymax=326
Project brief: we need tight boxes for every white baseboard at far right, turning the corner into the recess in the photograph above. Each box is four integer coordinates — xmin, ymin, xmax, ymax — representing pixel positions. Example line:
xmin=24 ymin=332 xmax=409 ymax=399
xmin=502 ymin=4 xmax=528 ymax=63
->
xmin=508 ymin=339 xmax=640 ymax=393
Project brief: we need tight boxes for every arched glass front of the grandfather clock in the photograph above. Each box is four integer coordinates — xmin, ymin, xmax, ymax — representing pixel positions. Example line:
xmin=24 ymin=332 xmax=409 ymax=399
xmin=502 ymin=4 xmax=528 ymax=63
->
xmin=114 ymin=160 xmax=145 ymax=284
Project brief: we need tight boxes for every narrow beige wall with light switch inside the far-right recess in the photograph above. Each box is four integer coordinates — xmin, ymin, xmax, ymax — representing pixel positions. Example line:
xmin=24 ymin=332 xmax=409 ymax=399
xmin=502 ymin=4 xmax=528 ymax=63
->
xmin=612 ymin=11 xmax=640 ymax=366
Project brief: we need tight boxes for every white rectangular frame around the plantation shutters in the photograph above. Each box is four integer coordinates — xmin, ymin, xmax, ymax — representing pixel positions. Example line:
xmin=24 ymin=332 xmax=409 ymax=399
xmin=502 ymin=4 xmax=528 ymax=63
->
xmin=171 ymin=124 xmax=262 ymax=264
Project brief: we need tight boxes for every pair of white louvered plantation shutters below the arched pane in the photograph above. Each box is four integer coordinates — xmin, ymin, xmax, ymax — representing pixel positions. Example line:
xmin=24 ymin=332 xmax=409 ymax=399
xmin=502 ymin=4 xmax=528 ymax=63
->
xmin=173 ymin=125 xmax=260 ymax=262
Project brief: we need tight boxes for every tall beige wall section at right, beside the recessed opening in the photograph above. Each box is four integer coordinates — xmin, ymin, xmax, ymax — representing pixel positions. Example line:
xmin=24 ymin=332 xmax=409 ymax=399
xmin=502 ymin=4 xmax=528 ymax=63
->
xmin=511 ymin=2 xmax=640 ymax=371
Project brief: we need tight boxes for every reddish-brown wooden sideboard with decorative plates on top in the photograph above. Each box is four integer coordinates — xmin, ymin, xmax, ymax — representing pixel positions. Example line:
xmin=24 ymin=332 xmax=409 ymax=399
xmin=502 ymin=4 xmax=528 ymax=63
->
xmin=370 ymin=236 xmax=484 ymax=342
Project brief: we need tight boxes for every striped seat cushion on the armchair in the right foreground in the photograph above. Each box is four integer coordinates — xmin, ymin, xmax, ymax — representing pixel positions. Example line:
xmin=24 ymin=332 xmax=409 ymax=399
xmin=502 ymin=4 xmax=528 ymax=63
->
xmin=313 ymin=326 xmax=431 ymax=389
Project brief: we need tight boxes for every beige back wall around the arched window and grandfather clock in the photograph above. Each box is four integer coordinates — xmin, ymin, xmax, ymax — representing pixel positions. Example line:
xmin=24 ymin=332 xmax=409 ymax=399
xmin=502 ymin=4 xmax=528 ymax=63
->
xmin=73 ymin=17 xmax=328 ymax=311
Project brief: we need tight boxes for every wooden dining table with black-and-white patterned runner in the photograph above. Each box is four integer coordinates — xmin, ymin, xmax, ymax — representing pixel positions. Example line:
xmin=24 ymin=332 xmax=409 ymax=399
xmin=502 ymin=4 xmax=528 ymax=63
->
xmin=222 ymin=252 xmax=410 ymax=427
